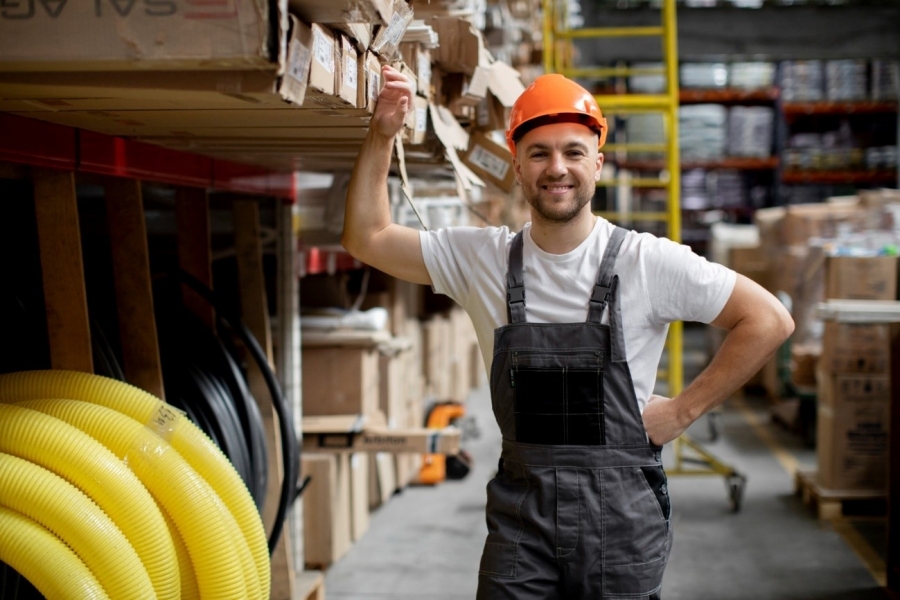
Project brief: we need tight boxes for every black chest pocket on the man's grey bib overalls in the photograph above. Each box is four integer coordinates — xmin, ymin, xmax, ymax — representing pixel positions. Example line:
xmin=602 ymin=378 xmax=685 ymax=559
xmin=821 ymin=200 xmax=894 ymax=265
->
xmin=509 ymin=350 xmax=606 ymax=446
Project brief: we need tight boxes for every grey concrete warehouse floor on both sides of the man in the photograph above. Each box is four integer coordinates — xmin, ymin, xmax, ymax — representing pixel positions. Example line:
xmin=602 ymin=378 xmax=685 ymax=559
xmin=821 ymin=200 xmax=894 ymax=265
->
xmin=325 ymin=330 xmax=887 ymax=600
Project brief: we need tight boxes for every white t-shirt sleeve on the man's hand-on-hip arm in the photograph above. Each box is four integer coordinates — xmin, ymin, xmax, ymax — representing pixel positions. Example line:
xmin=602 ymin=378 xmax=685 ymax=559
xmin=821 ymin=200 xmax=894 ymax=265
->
xmin=645 ymin=238 xmax=737 ymax=323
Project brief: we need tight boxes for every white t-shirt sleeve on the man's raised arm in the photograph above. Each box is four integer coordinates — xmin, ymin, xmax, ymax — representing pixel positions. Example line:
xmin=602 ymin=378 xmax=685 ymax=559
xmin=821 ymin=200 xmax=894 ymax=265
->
xmin=419 ymin=227 xmax=493 ymax=306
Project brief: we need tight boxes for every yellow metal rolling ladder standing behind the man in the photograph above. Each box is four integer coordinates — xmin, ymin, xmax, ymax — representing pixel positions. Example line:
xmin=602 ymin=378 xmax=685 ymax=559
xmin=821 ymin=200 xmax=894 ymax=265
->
xmin=542 ymin=0 xmax=746 ymax=511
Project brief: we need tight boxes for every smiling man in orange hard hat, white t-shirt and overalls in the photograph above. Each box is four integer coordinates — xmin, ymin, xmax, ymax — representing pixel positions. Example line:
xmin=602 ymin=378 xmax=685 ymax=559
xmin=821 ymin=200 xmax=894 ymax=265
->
xmin=342 ymin=67 xmax=793 ymax=600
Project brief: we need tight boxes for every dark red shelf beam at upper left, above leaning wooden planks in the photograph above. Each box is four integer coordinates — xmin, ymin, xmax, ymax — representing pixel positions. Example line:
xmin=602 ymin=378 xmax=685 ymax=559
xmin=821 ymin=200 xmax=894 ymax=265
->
xmin=0 ymin=113 xmax=296 ymax=202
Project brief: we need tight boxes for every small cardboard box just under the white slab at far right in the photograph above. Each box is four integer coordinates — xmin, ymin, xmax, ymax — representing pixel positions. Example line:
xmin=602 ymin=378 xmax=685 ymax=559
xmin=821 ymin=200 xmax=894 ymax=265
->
xmin=820 ymin=321 xmax=891 ymax=374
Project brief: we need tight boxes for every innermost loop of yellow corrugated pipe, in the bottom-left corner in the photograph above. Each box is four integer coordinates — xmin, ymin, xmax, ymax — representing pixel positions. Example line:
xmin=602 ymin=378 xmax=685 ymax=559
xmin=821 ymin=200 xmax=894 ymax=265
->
xmin=0 ymin=507 xmax=109 ymax=600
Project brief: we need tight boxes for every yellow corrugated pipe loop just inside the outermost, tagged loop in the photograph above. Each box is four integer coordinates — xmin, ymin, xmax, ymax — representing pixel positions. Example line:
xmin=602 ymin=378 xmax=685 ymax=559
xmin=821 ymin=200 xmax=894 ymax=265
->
xmin=19 ymin=400 xmax=261 ymax=600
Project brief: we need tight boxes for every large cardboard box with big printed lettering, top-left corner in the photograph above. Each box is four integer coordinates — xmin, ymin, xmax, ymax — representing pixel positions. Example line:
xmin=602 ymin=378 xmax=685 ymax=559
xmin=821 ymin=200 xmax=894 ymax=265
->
xmin=0 ymin=0 xmax=277 ymax=71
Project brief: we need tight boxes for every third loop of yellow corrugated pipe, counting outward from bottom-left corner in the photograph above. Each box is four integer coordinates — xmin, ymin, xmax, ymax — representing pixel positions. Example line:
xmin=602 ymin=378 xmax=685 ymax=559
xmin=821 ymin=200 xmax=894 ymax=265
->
xmin=0 ymin=404 xmax=181 ymax=600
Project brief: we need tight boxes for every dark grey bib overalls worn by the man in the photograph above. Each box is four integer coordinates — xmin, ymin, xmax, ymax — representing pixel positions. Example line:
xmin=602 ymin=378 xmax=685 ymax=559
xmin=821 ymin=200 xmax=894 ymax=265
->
xmin=478 ymin=227 xmax=672 ymax=600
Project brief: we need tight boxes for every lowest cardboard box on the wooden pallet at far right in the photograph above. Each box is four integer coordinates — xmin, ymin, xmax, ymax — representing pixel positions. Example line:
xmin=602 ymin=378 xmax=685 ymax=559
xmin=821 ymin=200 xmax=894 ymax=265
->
xmin=816 ymin=370 xmax=890 ymax=490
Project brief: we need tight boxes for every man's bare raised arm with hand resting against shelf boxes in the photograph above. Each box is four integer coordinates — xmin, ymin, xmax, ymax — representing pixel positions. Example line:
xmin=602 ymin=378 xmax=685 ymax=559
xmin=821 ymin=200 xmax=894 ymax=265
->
xmin=341 ymin=66 xmax=431 ymax=285
